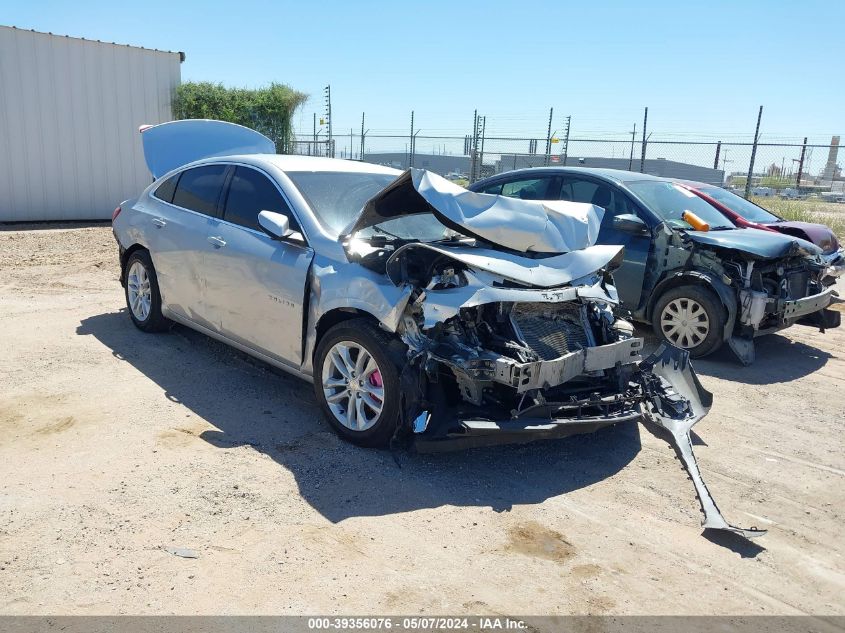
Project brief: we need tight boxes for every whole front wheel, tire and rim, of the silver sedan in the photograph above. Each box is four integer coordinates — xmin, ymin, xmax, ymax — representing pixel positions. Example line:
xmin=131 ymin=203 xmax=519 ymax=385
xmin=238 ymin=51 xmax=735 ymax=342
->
xmin=314 ymin=319 xmax=406 ymax=447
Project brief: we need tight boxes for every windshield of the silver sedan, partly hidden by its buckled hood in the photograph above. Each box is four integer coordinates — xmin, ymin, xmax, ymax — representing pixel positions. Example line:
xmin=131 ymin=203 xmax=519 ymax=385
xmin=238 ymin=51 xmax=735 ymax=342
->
xmin=286 ymin=171 xmax=398 ymax=235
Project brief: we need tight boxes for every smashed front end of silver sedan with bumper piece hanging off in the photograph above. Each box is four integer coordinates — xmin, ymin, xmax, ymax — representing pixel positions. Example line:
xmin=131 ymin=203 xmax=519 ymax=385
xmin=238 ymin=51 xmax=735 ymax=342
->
xmin=382 ymin=249 xmax=763 ymax=537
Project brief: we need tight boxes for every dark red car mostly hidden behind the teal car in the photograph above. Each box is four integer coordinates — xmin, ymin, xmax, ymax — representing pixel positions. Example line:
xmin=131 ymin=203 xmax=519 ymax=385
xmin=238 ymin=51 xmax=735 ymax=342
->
xmin=679 ymin=180 xmax=845 ymax=266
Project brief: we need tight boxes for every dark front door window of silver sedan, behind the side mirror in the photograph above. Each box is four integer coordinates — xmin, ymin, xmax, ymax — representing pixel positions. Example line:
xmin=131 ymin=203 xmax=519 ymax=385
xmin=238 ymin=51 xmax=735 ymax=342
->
xmin=223 ymin=167 xmax=299 ymax=231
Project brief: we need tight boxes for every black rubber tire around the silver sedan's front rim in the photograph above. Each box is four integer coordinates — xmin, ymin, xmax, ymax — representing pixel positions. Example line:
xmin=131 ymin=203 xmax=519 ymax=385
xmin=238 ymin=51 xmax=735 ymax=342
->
xmin=314 ymin=319 xmax=404 ymax=447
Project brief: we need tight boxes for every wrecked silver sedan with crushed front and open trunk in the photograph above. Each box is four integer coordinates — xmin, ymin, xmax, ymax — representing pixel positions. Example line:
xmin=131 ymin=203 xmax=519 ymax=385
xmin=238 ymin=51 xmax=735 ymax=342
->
xmin=113 ymin=121 xmax=760 ymax=536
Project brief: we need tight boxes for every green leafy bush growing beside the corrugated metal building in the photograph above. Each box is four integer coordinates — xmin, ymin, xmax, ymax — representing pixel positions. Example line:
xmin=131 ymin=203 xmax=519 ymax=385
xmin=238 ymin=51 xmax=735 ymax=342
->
xmin=173 ymin=81 xmax=308 ymax=154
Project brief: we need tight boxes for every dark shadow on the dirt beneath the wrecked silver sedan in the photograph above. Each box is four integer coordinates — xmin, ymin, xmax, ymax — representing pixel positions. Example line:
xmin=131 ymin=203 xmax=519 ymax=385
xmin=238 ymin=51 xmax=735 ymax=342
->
xmin=77 ymin=311 xmax=648 ymax=522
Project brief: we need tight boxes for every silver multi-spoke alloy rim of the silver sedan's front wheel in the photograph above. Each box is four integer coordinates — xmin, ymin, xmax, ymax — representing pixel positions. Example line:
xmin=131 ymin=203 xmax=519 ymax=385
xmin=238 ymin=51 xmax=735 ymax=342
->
xmin=321 ymin=341 xmax=384 ymax=431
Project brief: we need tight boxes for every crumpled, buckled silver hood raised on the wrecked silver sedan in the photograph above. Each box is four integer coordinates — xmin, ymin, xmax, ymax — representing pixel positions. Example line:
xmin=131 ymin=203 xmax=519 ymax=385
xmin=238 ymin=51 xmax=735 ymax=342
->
xmin=344 ymin=168 xmax=604 ymax=253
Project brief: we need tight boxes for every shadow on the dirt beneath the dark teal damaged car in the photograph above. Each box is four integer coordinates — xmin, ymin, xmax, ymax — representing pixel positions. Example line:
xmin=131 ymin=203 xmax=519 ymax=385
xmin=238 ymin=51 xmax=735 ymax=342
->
xmin=636 ymin=325 xmax=833 ymax=385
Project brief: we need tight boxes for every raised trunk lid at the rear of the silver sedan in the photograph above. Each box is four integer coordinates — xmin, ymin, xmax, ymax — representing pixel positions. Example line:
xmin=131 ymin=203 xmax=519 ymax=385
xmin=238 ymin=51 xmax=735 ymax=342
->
xmin=139 ymin=119 xmax=276 ymax=178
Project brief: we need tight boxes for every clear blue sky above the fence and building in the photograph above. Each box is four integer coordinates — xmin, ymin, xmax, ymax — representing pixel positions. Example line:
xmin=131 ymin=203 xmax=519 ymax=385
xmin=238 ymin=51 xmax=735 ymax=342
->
xmin=0 ymin=0 xmax=845 ymax=141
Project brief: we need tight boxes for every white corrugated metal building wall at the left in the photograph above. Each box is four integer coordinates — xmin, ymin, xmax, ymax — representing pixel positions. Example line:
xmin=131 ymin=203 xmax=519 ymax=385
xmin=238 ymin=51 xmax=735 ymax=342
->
xmin=0 ymin=27 xmax=180 ymax=222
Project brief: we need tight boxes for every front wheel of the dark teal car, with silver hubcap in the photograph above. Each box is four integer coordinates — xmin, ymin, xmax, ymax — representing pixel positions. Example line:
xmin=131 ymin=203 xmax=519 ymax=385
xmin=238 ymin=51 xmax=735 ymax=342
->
xmin=652 ymin=286 xmax=726 ymax=358
